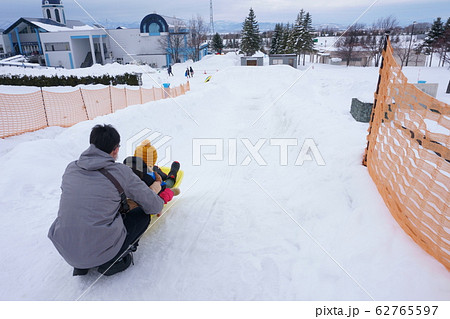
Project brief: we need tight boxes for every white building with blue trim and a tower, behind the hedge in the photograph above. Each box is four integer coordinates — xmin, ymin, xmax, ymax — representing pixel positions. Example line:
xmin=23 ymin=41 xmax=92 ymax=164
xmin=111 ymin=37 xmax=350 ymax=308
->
xmin=0 ymin=0 xmax=207 ymax=69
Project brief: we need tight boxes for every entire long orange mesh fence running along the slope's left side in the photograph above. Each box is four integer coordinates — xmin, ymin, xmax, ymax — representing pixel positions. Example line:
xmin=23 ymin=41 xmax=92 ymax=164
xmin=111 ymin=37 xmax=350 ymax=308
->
xmin=0 ymin=82 xmax=189 ymax=138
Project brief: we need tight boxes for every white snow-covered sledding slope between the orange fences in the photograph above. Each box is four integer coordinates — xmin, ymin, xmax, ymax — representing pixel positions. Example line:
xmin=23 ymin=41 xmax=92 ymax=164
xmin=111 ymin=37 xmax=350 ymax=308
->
xmin=0 ymin=54 xmax=450 ymax=300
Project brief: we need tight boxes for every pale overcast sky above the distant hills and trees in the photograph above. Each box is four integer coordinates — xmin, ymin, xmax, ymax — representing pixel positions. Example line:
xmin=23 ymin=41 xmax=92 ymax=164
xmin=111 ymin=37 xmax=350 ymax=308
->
xmin=0 ymin=0 xmax=450 ymax=28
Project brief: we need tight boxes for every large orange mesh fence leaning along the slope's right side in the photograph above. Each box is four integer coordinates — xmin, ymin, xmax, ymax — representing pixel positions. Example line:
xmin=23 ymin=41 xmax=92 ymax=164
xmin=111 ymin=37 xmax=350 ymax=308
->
xmin=364 ymin=41 xmax=450 ymax=270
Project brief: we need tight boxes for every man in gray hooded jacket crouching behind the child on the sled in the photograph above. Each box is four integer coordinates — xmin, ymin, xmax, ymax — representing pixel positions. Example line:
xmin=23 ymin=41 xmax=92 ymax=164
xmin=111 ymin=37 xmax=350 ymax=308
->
xmin=48 ymin=125 xmax=164 ymax=276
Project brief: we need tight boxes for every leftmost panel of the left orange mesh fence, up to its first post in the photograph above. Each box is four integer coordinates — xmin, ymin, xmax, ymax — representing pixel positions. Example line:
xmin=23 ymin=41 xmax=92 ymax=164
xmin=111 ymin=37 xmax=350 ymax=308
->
xmin=0 ymin=91 xmax=48 ymax=137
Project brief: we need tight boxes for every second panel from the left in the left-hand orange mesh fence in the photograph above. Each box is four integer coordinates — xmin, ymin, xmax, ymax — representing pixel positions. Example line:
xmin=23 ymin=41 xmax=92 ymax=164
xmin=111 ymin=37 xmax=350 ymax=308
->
xmin=42 ymin=90 xmax=89 ymax=127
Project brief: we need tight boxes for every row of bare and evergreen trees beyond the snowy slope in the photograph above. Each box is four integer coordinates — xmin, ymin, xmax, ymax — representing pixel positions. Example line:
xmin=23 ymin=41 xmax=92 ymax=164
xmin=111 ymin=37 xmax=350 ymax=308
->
xmin=161 ymin=8 xmax=450 ymax=67
